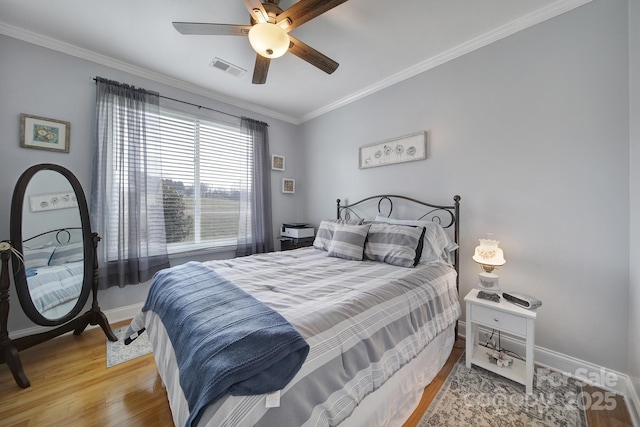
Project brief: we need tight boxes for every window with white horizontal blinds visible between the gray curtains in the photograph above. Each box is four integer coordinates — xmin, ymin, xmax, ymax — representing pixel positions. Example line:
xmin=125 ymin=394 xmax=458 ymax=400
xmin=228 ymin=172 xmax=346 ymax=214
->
xmin=160 ymin=109 xmax=253 ymax=253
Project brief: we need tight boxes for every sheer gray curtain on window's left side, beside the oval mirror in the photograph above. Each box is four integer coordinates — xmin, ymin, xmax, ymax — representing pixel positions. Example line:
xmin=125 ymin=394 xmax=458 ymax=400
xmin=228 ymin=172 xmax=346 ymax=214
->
xmin=90 ymin=78 xmax=169 ymax=288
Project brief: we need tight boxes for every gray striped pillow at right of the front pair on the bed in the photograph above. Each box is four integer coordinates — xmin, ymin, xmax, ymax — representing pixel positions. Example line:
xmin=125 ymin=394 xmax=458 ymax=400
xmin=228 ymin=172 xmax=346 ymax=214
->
xmin=364 ymin=222 xmax=424 ymax=267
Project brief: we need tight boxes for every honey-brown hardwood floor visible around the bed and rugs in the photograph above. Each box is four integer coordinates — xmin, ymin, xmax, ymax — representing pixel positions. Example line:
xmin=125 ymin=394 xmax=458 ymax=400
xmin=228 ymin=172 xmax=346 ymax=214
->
xmin=0 ymin=322 xmax=631 ymax=427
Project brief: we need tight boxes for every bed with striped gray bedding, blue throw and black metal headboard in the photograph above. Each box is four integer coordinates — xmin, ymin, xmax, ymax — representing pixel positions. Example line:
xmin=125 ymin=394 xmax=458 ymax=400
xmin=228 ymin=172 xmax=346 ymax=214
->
xmin=125 ymin=195 xmax=461 ymax=426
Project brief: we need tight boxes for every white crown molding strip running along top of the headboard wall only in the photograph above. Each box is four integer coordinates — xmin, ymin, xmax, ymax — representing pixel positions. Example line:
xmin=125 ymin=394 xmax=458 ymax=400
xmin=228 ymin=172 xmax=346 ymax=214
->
xmin=300 ymin=0 xmax=593 ymax=122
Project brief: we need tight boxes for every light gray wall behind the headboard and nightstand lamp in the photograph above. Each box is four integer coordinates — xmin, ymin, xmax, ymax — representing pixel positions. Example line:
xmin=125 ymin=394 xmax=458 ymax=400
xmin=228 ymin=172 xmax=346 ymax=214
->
xmin=303 ymin=0 xmax=629 ymax=372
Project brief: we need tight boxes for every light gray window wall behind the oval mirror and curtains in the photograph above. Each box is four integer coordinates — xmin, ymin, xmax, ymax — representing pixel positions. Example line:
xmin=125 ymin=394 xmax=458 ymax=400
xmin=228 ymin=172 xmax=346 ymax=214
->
xmin=0 ymin=35 xmax=302 ymax=331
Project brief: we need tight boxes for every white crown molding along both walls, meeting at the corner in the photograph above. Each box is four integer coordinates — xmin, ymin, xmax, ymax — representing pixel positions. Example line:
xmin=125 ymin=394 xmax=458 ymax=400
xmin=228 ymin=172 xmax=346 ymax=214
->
xmin=0 ymin=0 xmax=593 ymax=125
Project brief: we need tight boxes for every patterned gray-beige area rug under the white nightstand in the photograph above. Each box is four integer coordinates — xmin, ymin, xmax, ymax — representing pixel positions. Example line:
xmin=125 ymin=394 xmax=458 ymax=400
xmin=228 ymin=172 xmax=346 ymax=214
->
xmin=418 ymin=353 xmax=587 ymax=427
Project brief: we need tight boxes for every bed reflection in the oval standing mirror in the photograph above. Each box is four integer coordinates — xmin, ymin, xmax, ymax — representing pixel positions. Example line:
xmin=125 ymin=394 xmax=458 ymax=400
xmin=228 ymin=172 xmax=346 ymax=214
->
xmin=23 ymin=227 xmax=84 ymax=319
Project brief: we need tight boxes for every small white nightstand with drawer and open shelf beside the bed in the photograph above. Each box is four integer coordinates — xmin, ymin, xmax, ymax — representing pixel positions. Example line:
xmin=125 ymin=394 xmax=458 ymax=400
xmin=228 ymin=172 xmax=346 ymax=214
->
xmin=464 ymin=289 xmax=536 ymax=394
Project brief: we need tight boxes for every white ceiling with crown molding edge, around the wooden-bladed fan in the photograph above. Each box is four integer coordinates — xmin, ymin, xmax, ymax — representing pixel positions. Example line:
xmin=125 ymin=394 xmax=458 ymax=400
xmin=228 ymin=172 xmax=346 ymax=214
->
xmin=0 ymin=0 xmax=591 ymax=123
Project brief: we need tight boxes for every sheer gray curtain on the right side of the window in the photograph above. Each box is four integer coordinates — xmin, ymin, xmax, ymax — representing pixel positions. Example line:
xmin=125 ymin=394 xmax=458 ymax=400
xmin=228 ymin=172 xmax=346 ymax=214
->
xmin=236 ymin=117 xmax=273 ymax=256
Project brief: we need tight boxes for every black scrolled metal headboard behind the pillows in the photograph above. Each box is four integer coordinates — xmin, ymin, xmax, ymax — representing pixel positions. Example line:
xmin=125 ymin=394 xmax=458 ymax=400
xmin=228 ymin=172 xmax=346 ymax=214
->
xmin=336 ymin=194 xmax=460 ymax=320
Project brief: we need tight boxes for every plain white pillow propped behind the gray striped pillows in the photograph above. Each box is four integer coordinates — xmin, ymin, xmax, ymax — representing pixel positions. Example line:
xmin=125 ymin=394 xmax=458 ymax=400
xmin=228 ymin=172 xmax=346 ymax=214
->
xmin=375 ymin=215 xmax=458 ymax=264
